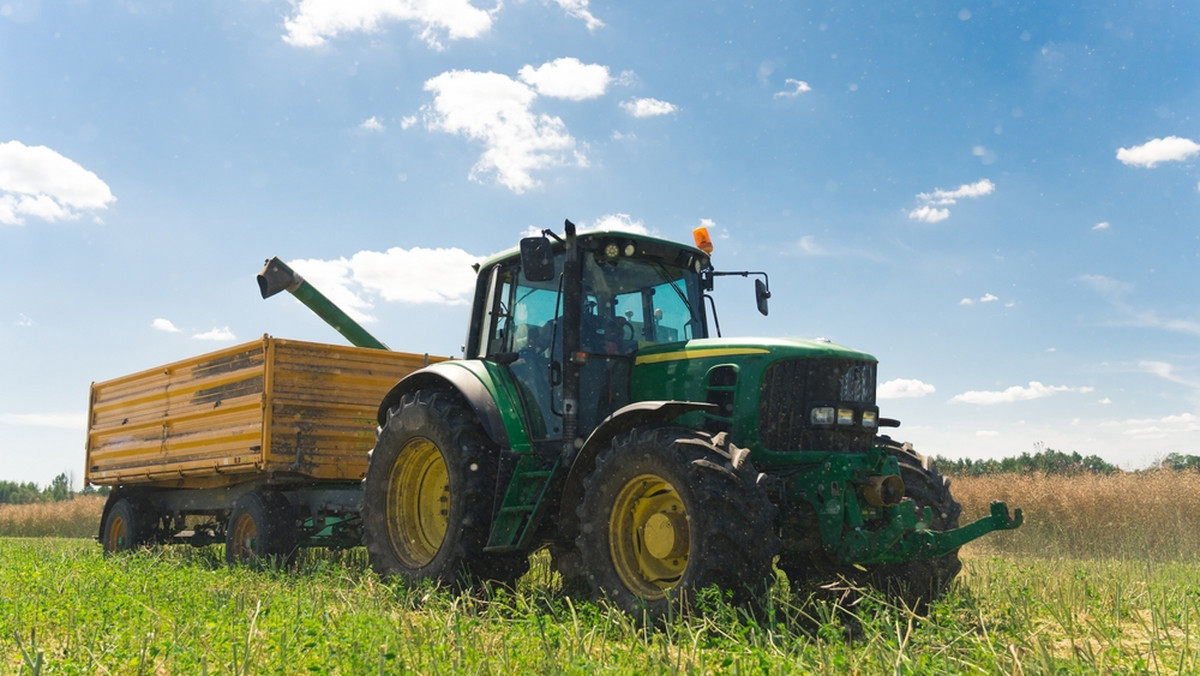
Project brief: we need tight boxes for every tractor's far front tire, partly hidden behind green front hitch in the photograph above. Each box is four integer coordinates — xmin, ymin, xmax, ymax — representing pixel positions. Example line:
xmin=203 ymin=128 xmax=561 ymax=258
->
xmin=869 ymin=437 xmax=962 ymax=611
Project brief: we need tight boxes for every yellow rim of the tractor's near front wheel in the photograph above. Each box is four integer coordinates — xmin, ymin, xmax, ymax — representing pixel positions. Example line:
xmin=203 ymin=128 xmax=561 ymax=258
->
xmin=608 ymin=474 xmax=691 ymax=599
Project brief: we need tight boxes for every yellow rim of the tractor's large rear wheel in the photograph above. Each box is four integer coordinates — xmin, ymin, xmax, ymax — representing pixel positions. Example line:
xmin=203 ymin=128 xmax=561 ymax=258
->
xmin=388 ymin=437 xmax=450 ymax=568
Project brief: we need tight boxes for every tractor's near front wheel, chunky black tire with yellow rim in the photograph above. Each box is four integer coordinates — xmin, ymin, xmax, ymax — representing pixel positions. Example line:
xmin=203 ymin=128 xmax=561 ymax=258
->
xmin=568 ymin=427 xmax=779 ymax=620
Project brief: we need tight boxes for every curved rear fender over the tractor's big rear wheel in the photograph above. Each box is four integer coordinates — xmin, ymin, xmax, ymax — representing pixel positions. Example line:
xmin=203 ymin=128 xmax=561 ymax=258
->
xmin=377 ymin=359 xmax=529 ymax=451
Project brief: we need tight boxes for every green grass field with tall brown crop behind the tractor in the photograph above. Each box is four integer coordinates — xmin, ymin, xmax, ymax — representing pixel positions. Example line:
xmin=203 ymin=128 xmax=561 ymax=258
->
xmin=0 ymin=473 xmax=1200 ymax=674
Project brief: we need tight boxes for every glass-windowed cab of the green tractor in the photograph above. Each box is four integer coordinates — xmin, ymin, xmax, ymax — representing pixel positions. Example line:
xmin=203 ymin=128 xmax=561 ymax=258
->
xmin=466 ymin=232 xmax=709 ymax=444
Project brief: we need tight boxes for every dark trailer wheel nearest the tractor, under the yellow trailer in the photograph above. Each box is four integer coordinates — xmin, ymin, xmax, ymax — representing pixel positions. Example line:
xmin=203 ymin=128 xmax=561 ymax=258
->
xmin=226 ymin=490 xmax=296 ymax=566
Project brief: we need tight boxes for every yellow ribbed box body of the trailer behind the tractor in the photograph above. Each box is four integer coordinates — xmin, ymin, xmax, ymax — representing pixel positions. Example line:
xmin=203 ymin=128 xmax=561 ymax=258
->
xmin=85 ymin=336 xmax=440 ymax=487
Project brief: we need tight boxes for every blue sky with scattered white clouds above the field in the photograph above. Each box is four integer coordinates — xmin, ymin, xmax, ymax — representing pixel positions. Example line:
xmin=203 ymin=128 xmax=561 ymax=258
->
xmin=0 ymin=0 xmax=1200 ymax=486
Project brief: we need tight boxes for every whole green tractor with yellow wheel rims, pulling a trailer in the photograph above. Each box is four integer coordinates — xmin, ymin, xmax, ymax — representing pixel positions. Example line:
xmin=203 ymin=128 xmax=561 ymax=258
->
xmin=352 ymin=221 xmax=1021 ymax=617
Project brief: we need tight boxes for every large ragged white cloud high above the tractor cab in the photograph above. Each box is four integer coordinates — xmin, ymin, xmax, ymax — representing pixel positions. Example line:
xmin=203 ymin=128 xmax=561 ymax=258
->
xmin=424 ymin=71 xmax=587 ymax=193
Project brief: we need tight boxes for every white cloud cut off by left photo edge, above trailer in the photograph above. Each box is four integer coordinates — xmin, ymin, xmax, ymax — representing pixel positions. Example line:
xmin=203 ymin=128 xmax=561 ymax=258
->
xmin=0 ymin=140 xmax=116 ymax=226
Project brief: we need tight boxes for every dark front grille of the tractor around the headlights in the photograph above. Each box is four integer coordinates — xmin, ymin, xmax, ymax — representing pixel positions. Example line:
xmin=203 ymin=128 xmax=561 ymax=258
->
xmin=758 ymin=359 xmax=876 ymax=453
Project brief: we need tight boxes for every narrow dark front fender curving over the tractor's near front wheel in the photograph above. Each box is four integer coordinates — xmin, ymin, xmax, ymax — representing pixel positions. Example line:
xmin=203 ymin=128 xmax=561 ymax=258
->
xmin=559 ymin=401 xmax=720 ymax=538
